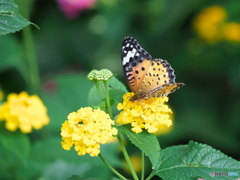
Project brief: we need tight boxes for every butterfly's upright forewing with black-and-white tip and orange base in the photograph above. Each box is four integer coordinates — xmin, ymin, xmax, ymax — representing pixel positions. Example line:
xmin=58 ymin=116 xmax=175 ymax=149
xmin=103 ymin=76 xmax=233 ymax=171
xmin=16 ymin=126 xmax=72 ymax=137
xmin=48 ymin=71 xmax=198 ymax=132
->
xmin=122 ymin=37 xmax=152 ymax=93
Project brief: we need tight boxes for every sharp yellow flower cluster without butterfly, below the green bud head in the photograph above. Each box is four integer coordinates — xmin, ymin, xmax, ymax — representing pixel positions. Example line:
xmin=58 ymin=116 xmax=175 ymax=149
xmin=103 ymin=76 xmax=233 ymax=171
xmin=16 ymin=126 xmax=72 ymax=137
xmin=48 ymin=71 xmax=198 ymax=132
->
xmin=61 ymin=107 xmax=117 ymax=156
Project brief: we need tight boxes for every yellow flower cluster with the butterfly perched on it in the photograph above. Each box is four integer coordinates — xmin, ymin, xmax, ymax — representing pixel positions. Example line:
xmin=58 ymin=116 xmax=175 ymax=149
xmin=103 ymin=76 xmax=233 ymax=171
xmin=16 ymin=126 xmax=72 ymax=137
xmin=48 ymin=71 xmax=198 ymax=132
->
xmin=117 ymin=93 xmax=172 ymax=133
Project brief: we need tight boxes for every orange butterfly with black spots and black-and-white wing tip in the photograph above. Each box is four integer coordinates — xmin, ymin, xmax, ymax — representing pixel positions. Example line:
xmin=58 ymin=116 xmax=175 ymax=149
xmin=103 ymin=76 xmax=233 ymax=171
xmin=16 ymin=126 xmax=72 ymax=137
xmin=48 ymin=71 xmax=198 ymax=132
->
xmin=122 ymin=37 xmax=185 ymax=101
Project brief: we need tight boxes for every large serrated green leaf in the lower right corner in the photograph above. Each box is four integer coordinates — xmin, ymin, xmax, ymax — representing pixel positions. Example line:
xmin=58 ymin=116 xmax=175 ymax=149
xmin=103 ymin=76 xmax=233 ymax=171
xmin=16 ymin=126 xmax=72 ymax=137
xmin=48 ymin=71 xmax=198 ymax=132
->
xmin=152 ymin=141 xmax=240 ymax=180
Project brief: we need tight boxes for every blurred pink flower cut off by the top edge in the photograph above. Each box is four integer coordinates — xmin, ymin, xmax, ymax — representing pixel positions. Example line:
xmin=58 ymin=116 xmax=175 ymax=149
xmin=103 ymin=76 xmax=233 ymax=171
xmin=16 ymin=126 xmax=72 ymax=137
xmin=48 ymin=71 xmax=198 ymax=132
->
xmin=56 ymin=0 xmax=96 ymax=19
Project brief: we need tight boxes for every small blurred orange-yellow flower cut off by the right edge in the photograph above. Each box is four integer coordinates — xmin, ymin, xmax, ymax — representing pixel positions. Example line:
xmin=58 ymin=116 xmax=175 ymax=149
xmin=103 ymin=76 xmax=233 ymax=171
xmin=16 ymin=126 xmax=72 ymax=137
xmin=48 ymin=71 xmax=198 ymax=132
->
xmin=223 ymin=22 xmax=240 ymax=42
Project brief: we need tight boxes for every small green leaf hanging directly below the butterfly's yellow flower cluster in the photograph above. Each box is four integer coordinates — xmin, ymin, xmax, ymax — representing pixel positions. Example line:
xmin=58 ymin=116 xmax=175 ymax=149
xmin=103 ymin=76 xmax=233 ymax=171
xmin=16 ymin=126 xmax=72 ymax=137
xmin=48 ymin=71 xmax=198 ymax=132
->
xmin=116 ymin=125 xmax=160 ymax=167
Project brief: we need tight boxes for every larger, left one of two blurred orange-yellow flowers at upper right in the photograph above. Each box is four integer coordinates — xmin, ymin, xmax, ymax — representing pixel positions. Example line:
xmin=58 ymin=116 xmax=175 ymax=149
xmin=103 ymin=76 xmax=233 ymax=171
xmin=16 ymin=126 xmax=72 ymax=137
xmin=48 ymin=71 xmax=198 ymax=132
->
xmin=193 ymin=6 xmax=227 ymax=43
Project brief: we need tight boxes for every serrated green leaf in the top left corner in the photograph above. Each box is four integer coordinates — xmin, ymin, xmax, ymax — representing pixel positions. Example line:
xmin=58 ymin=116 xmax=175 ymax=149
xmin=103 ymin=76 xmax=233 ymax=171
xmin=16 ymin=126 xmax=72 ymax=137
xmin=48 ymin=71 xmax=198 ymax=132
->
xmin=0 ymin=0 xmax=32 ymax=35
